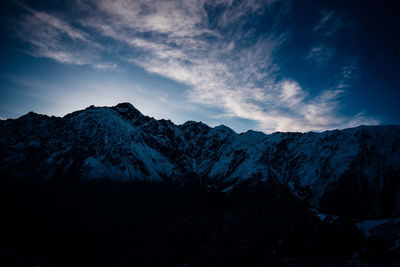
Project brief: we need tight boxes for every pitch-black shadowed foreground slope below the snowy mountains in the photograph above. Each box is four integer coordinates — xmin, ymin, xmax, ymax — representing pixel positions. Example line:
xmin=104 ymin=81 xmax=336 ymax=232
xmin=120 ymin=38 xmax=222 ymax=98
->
xmin=0 ymin=178 xmax=390 ymax=266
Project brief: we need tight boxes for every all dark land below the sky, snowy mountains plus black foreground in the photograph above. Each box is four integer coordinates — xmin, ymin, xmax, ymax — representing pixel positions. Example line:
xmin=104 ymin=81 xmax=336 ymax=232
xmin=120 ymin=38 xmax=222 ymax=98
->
xmin=0 ymin=103 xmax=400 ymax=266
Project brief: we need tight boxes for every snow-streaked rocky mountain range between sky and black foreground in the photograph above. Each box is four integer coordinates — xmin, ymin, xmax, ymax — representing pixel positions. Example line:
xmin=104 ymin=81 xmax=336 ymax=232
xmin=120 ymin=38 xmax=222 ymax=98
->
xmin=0 ymin=103 xmax=400 ymax=216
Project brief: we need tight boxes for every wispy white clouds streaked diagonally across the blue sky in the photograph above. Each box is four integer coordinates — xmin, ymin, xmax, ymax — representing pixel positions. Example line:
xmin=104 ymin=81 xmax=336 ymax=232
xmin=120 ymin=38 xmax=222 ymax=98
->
xmin=10 ymin=0 xmax=378 ymax=132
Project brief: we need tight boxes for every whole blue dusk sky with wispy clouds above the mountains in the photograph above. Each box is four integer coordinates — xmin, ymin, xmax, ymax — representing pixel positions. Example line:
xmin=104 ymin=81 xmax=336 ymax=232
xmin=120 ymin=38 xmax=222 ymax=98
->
xmin=0 ymin=0 xmax=400 ymax=133
